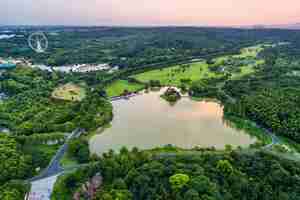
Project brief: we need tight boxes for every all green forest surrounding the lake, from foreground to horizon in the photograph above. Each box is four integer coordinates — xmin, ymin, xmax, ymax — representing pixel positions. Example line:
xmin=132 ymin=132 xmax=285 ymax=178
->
xmin=0 ymin=27 xmax=300 ymax=200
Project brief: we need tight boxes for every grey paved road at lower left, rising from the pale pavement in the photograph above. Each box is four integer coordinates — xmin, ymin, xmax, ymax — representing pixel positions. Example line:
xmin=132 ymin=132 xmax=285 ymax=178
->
xmin=29 ymin=129 xmax=84 ymax=182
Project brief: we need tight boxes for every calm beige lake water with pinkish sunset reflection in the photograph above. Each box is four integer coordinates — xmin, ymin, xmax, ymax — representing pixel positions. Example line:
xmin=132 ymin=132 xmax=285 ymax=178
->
xmin=90 ymin=89 xmax=255 ymax=154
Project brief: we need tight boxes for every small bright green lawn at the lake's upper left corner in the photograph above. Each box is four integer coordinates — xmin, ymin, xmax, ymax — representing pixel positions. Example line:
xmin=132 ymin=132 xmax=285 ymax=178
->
xmin=106 ymin=80 xmax=144 ymax=97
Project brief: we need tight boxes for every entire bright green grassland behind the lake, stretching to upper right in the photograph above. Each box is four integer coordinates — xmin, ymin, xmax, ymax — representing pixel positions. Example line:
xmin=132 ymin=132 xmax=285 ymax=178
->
xmin=106 ymin=44 xmax=271 ymax=94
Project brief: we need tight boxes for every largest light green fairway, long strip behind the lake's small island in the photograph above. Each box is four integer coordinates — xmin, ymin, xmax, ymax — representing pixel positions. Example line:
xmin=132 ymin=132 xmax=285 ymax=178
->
xmin=132 ymin=62 xmax=218 ymax=87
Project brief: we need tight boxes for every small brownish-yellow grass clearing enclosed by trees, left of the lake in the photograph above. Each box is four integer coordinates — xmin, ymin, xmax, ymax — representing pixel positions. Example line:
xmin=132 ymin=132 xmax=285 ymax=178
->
xmin=52 ymin=83 xmax=86 ymax=101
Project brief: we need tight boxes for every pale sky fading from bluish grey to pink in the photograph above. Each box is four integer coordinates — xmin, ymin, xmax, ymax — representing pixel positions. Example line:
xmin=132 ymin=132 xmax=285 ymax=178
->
xmin=0 ymin=0 xmax=300 ymax=26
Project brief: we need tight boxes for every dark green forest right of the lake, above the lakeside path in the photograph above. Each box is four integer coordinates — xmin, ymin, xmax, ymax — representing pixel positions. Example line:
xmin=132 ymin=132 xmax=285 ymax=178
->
xmin=222 ymin=43 xmax=300 ymax=143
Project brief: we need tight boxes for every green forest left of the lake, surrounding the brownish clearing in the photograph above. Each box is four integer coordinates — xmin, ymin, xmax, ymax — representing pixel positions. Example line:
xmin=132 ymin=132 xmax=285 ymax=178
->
xmin=0 ymin=66 xmax=112 ymax=200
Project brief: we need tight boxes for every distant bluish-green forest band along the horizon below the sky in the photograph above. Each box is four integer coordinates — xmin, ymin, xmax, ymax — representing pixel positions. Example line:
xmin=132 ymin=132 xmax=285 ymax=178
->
xmin=0 ymin=27 xmax=299 ymax=67
